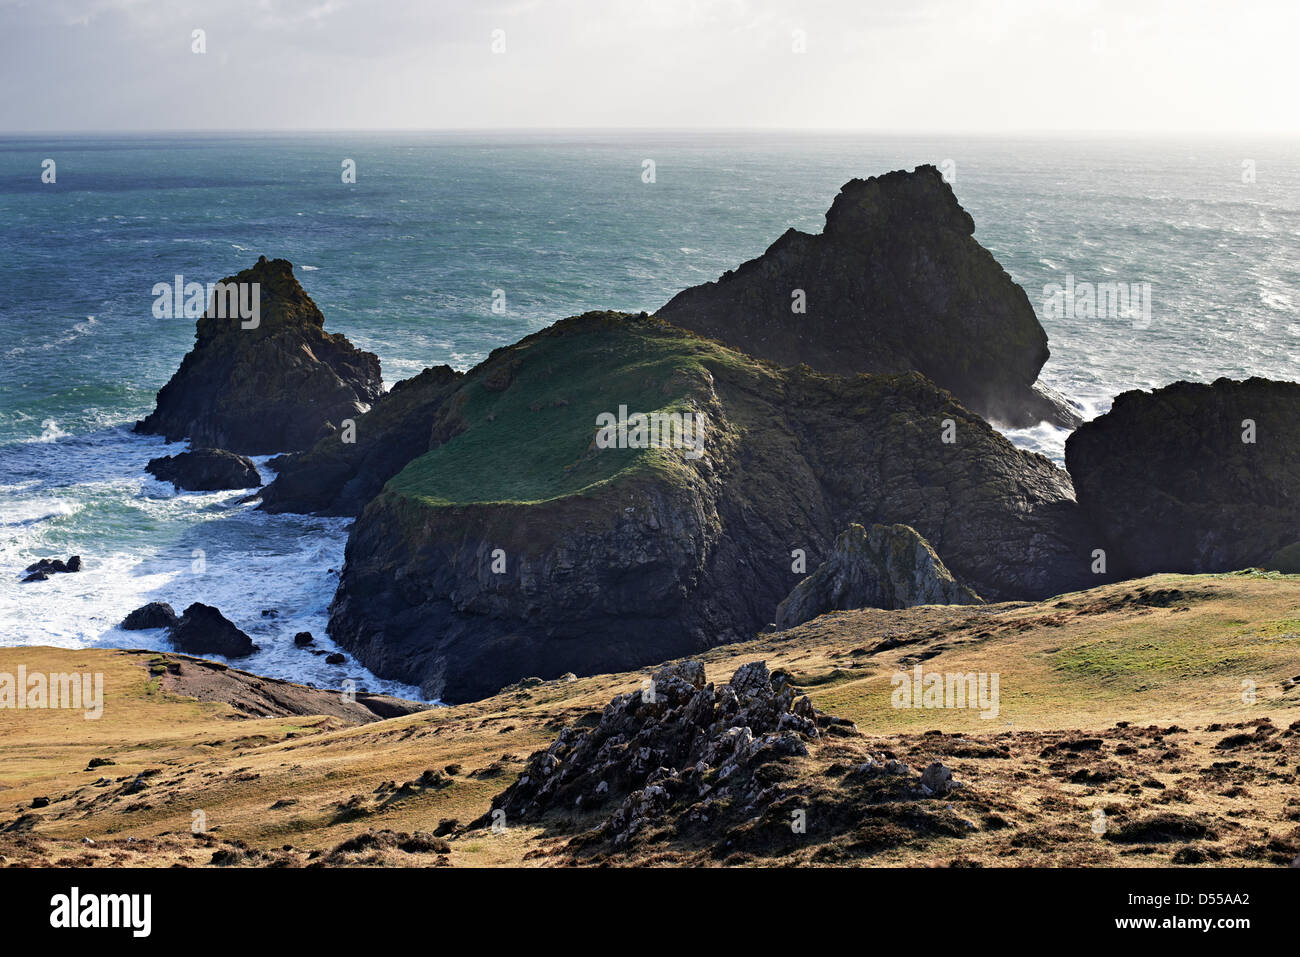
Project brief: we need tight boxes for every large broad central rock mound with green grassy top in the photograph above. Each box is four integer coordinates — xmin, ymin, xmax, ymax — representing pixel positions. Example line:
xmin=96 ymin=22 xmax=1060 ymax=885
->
xmin=330 ymin=313 xmax=1096 ymax=701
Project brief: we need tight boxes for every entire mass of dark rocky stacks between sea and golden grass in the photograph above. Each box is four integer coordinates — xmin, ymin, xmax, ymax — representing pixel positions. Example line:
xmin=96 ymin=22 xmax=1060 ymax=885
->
xmin=119 ymin=166 xmax=1300 ymax=702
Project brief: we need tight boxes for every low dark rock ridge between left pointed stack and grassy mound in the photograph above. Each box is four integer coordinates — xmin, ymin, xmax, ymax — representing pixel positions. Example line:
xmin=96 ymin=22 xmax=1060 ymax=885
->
xmin=261 ymin=365 xmax=462 ymax=515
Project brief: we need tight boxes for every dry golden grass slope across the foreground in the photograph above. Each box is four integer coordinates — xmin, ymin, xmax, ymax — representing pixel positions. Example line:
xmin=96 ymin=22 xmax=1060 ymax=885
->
xmin=0 ymin=573 xmax=1300 ymax=866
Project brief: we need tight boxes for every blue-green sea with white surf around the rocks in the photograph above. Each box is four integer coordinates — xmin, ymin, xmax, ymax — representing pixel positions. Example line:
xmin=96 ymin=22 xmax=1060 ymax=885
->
xmin=0 ymin=131 xmax=1300 ymax=697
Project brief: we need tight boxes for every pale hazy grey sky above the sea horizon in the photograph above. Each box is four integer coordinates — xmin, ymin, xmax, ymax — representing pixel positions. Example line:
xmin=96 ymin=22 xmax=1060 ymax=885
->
xmin=0 ymin=0 xmax=1300 ymax=137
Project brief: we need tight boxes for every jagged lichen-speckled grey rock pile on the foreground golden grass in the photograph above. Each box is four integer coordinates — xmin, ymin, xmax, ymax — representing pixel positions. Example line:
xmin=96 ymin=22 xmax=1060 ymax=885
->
xmin=475 ymin=661 xmax=857 ymax=846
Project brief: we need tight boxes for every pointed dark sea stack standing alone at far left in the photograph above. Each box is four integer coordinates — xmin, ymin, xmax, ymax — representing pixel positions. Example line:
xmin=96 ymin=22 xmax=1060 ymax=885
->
xmin=135 ymin=256 xmax=382 ymax=455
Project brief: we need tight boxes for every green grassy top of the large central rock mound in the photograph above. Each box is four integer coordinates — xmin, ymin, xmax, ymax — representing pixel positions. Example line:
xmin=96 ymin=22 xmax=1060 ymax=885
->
xmin=386 ymin=312 xmax=762 ymax=507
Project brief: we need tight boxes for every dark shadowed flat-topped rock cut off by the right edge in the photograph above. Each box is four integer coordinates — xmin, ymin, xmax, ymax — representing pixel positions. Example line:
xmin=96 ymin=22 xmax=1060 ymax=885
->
xmin=1065 ymin=378 xmax=1300 ymax=577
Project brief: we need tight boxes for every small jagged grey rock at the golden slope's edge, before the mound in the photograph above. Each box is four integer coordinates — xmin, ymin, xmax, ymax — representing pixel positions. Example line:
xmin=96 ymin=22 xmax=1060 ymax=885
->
xmin=776 ymin=524 xmax=979 ymax=629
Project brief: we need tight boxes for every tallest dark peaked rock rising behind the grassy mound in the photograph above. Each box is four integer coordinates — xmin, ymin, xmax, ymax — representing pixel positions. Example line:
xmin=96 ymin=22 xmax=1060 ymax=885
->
xmin=657 ymin=166 xmax=1079 ymax=428
